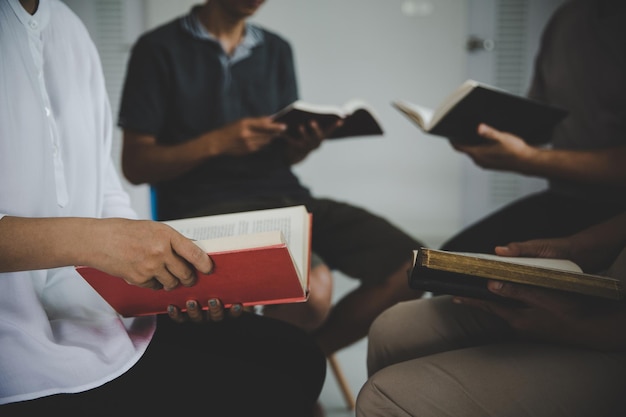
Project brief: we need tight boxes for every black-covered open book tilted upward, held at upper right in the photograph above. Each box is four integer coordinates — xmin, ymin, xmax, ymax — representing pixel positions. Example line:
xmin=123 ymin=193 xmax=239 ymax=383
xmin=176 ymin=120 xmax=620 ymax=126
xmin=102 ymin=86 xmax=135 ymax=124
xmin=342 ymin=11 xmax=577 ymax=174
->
xmin=392 ymin=80 xmax=567 ymax=144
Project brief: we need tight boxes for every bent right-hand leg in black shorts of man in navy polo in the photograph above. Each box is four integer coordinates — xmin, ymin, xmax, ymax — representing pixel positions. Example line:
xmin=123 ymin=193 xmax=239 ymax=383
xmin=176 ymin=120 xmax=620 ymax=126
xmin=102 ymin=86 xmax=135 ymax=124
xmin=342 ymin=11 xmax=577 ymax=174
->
xmin=306 ymin=199 xmax=422 ymax=356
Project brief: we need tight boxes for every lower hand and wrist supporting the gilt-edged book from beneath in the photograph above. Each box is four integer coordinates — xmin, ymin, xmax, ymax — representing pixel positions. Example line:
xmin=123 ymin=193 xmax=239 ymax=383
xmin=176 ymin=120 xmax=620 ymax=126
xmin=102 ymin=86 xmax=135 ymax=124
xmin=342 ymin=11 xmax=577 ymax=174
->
xmin=454 ymin=281 xmax=626 ymax=350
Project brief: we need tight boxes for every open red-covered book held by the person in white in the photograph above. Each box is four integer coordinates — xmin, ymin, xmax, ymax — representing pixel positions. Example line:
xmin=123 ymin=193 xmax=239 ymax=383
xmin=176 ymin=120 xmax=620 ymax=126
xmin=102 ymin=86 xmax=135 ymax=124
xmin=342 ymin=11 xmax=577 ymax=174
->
xmin=76 ymin=206 xmax=311 ymax=317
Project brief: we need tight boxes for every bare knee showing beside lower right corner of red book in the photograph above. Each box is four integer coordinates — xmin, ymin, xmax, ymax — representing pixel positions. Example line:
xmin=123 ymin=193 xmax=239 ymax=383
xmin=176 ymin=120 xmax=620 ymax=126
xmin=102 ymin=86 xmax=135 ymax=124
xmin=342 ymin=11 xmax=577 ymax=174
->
xmin=263 ymin=264 xmax=333 ymax=332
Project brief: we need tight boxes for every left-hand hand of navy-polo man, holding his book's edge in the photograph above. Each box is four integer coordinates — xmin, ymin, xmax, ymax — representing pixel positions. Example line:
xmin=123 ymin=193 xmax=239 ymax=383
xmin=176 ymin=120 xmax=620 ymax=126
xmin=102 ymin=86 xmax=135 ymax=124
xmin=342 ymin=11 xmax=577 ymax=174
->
xmin=208 ymin=117 xmax=287 ymax=156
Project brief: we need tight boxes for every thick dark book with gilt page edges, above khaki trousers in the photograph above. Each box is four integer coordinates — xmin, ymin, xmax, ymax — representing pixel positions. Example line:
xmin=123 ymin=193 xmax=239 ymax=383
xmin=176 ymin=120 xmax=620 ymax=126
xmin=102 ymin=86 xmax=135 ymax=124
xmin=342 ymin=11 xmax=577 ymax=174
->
xmin=409 ymin=248 xmax=624 ymax=301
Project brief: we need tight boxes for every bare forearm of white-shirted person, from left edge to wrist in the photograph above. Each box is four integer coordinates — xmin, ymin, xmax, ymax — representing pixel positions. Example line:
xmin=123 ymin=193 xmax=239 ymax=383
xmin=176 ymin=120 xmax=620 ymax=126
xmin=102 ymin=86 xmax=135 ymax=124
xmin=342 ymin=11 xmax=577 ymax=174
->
xmin=0 ymin=216 xmax=98 ymax=272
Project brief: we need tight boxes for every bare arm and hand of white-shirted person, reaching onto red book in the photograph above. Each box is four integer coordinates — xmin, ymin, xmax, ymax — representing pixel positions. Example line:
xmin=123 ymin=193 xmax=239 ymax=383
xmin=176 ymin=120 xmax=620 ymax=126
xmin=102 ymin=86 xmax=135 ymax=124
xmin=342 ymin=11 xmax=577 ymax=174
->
xmin=0 ymin=216 xmax=213 ymax=289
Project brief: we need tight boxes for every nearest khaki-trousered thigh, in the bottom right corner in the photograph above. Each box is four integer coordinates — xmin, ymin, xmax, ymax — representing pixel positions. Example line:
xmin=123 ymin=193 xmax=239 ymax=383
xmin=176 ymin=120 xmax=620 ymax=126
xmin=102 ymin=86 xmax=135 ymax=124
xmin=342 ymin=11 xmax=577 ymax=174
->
xmin=356 ymin=343 xmax=626 ymax=417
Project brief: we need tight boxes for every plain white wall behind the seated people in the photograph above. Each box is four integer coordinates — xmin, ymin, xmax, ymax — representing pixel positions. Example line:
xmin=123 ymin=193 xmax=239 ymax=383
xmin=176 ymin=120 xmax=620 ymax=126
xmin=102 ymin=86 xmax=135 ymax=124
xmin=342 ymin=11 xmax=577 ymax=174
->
xmin=145 ymin=0 xmax=467 ymax=245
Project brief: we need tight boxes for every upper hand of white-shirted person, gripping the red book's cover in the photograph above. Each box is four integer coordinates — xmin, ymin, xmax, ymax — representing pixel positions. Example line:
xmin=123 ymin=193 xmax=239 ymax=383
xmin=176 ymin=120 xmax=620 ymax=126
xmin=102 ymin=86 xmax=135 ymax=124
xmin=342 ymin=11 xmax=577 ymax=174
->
xmin=89 ymin=219 xmax=213 ymax=290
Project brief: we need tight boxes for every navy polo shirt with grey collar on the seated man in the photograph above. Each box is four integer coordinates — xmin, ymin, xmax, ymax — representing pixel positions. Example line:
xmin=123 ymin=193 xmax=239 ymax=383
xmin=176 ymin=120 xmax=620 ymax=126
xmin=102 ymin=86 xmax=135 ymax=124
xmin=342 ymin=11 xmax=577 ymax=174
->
xmin=118 ymin=12 xmax=309 ymax=219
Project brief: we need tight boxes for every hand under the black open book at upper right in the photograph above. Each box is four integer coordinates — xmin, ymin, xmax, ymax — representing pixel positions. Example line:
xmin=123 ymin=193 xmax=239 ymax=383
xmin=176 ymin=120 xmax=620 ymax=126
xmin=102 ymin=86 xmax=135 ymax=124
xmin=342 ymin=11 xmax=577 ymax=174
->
xmin=450 ymin=124 xmax=537 ymax=173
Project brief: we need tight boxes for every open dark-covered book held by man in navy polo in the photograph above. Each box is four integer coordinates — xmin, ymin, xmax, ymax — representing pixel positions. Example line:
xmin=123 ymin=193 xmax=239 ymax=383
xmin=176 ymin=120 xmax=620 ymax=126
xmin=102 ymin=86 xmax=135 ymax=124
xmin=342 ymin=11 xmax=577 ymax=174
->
xmin=272 ymin=99 xmax=383 ymax=139
